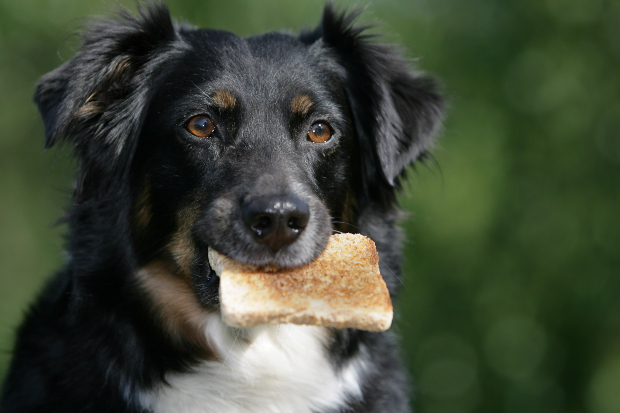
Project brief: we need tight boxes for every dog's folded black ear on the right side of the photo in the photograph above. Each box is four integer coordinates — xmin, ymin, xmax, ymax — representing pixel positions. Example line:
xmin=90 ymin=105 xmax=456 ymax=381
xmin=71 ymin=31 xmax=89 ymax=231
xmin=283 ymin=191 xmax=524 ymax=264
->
xmin=300 ymin=4 xmax=444 ymax=197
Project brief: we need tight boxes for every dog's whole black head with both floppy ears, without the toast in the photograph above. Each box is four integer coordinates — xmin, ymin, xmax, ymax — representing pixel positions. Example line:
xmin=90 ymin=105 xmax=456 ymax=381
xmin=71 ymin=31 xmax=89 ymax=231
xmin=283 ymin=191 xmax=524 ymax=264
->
xmin=35 ymin=5 xmax=442 ymax=316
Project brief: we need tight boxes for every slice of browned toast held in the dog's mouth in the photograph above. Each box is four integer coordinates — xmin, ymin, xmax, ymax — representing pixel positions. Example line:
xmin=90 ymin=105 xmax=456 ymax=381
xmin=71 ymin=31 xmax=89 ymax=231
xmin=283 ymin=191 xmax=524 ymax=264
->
xmin=209 ymin=234 xmax=393 ymax=331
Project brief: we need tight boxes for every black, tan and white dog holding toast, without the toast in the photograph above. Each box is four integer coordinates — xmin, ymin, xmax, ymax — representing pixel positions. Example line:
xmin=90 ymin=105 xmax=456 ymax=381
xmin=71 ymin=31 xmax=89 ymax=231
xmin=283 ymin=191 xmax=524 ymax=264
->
xmin=0 ymin=3 xmax=444 ymax=413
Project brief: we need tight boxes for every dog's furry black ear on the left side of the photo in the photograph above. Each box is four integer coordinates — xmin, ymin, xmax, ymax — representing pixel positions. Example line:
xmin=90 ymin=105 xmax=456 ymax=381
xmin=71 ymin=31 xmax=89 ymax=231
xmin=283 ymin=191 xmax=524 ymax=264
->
xmin=34 ymin=4 xmax=177 ymax=199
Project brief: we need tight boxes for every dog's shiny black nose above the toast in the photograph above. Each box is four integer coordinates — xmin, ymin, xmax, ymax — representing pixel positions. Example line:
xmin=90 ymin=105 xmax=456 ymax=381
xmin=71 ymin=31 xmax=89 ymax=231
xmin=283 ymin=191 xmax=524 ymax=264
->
xmin=241 ymin=195 xmax=310 ymax=252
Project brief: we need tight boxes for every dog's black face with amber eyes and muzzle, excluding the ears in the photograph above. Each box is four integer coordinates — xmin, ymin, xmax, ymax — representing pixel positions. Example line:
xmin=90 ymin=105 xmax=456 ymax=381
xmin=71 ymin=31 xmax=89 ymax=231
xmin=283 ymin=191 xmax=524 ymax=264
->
xmin=132 ymin=30 xmax=354 ymax=272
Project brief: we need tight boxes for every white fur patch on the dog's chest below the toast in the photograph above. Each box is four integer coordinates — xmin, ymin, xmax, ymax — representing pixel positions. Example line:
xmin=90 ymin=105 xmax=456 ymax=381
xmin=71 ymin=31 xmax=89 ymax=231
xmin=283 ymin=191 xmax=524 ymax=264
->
xmin=141 ymin=315 xmax=366 ymax=413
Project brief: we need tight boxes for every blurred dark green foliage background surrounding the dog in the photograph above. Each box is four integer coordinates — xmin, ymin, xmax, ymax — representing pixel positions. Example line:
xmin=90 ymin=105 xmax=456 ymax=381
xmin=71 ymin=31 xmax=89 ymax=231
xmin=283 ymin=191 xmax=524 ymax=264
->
xmin=0 ymin=0 xmax=620 ymax=413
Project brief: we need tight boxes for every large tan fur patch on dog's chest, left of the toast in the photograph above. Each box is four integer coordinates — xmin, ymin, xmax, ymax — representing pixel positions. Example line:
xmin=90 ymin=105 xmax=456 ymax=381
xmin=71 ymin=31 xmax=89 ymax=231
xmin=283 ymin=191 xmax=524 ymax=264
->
xmin=136 ymin=261 xmax=221 ymax=360
